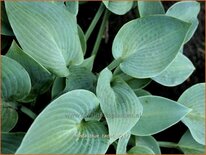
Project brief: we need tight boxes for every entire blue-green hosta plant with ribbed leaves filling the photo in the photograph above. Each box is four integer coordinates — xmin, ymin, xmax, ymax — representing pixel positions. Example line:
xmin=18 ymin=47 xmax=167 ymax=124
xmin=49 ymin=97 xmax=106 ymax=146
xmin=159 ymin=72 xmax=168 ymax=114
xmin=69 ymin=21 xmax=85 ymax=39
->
xmin=1 ymin=1 xmax=205 ymax=154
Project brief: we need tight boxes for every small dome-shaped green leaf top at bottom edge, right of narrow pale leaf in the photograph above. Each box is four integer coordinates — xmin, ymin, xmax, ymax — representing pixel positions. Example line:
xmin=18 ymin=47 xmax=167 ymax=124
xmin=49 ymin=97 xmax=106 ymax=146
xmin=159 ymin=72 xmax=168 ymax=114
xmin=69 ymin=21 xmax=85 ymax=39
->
xmin=128 ymin=145 xmax=155 ymax=154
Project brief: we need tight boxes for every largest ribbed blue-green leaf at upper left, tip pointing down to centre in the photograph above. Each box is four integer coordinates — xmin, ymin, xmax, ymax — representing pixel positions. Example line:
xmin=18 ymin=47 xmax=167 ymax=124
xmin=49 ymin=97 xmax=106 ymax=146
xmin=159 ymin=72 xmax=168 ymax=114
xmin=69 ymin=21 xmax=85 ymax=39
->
xmin=5 ymin=2 xmax=83 ymax=76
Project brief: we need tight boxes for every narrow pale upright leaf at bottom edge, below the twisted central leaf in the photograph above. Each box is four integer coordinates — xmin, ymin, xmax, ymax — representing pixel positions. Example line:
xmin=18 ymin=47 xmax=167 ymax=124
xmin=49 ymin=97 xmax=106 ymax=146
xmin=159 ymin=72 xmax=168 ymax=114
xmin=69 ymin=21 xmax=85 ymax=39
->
xmin=116 ymin=132 xmax=131 ymax=154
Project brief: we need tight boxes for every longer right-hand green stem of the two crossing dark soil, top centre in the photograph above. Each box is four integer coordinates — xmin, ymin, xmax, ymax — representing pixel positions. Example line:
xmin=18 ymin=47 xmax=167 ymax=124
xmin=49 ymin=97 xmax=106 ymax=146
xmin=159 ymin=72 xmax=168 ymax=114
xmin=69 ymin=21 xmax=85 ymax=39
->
xmin=92 ymin=10 xmax=110 ymax=57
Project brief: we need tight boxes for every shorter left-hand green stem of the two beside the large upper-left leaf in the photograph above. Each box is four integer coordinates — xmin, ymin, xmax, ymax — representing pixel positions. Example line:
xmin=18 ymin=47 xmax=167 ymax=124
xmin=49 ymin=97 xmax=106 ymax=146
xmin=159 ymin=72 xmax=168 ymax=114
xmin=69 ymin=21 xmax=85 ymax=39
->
xmin=85 ymin=4 xmax=105 ymax=41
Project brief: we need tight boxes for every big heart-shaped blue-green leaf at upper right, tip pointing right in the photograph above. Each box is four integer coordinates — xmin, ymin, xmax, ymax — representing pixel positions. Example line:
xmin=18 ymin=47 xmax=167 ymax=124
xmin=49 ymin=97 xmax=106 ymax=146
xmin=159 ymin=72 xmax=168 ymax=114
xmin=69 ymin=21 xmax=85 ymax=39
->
xmin=112 ymin=15 xmax=190 ymax=78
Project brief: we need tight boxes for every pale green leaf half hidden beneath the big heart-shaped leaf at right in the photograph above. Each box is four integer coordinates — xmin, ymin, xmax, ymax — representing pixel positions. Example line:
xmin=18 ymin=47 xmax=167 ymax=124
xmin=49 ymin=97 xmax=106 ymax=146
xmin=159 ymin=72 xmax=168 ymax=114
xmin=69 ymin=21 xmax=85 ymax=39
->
xmin=152 ymin=52 xmax=195 ymax=87
